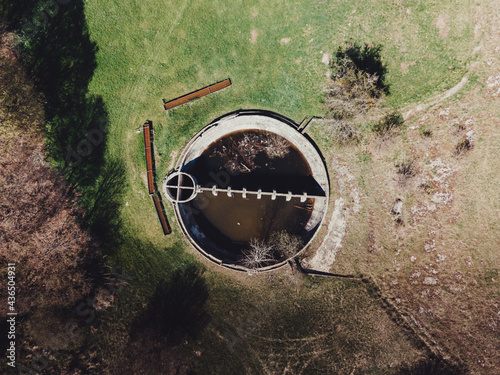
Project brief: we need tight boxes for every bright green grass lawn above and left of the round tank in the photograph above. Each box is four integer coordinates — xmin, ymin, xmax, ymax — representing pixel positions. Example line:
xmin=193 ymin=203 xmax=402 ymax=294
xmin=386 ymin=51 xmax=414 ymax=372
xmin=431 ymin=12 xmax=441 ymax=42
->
xmin=86 ymin=1 xmax=472 ymax=253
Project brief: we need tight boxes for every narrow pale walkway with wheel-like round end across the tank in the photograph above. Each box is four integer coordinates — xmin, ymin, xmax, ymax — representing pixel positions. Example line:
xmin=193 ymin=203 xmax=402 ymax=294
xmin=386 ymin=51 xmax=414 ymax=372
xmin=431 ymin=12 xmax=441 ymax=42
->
xmin=164 ymin=172 xmax=325 ymax=203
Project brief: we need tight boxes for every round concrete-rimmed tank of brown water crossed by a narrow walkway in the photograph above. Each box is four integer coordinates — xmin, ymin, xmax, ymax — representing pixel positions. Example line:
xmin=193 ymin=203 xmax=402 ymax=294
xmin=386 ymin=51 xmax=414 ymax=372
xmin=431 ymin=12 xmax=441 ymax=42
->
xmin=163 ymin=110 xmax=330 ymax=271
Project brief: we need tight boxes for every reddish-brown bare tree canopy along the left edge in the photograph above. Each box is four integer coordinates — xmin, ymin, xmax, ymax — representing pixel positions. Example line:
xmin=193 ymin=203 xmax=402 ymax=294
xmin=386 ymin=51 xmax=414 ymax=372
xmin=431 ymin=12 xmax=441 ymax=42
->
xmin=0 ymin=35 xmax=97 ymax=315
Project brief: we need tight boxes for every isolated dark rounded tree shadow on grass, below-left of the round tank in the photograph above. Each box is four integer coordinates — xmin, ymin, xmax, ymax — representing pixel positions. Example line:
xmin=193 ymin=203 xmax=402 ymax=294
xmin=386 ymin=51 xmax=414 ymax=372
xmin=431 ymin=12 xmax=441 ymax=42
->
xmin=134 ymin=264 xmax=209 ymax=346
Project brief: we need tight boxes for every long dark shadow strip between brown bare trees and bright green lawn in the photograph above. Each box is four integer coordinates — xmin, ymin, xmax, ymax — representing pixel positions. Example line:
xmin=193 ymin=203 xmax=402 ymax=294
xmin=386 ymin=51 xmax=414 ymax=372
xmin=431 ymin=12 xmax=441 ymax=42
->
xmin=0 ymin=0 xmax=125 ymax=239
